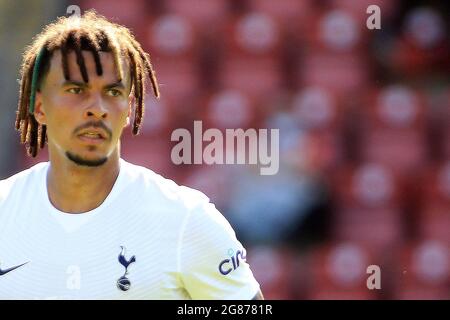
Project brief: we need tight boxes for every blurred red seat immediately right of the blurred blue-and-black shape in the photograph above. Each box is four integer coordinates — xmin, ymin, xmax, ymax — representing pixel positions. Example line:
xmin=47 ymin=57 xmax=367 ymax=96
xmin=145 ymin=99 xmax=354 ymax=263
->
xmin=331 ymin=163 xmax=404 ymax=253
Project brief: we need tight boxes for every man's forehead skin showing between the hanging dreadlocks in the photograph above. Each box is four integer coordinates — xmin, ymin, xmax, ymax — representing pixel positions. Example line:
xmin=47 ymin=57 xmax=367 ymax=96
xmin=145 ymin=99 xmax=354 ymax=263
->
xmin=48 ymin=50 xmax=130 ymax=84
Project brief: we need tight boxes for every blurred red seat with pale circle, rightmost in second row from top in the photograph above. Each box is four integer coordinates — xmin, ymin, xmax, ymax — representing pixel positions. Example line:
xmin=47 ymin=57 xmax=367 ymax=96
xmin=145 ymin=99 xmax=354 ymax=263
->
xmin=360 ymin=86 xmax=428 ymax=174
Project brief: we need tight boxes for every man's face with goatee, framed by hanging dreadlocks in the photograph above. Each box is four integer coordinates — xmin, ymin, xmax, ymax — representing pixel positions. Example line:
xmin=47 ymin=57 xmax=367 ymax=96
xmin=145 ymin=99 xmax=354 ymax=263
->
xmin=34 ymin=50 xmax=131 ymax=166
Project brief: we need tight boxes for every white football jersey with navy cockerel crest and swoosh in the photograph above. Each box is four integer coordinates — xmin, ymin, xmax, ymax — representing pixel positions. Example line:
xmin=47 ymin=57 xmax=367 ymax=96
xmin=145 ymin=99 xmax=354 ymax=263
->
xmin=0 ymin=159 xmax=259 ymax=299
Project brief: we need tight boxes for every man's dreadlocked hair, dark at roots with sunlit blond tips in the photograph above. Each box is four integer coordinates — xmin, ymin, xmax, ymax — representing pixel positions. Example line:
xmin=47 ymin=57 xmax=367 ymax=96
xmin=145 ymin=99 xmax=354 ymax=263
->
xmin=15 ymin=10 xmax=159 ymax=157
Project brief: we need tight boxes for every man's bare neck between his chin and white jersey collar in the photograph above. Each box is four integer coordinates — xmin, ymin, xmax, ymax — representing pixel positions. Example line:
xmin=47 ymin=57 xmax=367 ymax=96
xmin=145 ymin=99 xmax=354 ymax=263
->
xmin=47 ymin=150 xmax=120 ymax=213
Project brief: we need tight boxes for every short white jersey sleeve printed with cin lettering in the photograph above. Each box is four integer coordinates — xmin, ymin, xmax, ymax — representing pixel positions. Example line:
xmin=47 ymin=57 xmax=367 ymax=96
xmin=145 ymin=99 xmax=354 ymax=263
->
xmin=178 ymin=201 xmax=260 ymax=300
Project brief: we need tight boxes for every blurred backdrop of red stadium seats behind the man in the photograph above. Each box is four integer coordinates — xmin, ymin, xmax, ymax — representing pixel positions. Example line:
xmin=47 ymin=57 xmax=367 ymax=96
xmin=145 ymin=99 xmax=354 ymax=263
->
xmin=0 ymin=0 xmax=450 ymax=299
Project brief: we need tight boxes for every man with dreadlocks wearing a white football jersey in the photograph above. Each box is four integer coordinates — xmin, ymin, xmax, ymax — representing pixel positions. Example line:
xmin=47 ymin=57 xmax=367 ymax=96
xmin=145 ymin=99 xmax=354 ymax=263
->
xmin=0 ymin=12 xmax=263 ymax=299
